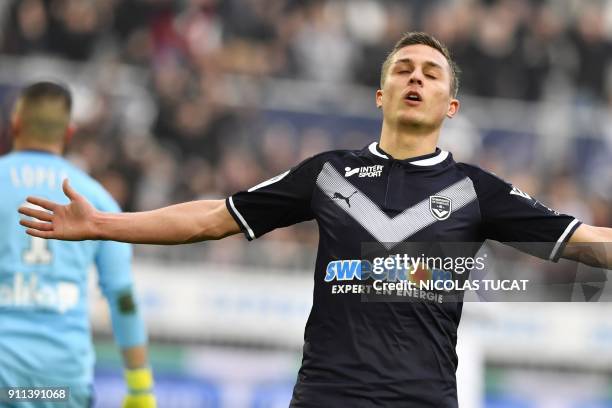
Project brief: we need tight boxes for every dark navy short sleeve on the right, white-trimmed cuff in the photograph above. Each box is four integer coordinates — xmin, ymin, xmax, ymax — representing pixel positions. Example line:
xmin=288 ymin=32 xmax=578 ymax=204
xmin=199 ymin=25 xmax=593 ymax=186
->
xmin=471 ymin=169 xmax=580 ymax=262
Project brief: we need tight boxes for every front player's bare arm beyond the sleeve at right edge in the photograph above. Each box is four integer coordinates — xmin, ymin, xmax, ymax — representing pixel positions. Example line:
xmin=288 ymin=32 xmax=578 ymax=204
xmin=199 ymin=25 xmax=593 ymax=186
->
xmin=562 ymin=224 xmax=612 ymax=269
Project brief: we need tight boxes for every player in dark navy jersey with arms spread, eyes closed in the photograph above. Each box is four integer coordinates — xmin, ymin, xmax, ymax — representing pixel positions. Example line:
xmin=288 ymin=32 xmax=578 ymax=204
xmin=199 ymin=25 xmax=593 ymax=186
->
xmin=20 ymin=33 xmax=612 ymax=408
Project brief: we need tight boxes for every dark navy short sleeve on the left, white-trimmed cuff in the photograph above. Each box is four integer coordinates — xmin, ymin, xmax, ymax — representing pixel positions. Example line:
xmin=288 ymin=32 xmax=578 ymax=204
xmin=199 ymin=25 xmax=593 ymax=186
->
xmin=225 ymin=156 xmax=321 ymax=241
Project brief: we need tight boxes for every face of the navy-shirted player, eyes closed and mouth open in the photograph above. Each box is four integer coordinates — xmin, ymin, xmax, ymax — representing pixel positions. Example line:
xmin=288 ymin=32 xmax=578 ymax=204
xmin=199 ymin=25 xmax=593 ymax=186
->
xmin=376 ymin=44 xmax=459 ymax=130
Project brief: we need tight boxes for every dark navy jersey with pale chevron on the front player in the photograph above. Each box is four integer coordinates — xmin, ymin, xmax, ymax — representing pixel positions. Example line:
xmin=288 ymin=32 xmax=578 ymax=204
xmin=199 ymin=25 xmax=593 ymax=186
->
xmin=226 ymin=143 xmax=579 ymax=408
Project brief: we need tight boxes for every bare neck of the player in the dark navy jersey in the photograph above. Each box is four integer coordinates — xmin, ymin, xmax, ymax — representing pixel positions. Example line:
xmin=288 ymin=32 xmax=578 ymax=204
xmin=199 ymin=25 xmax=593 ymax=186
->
xmin=378 ymin=122 xmax=440 ymax=160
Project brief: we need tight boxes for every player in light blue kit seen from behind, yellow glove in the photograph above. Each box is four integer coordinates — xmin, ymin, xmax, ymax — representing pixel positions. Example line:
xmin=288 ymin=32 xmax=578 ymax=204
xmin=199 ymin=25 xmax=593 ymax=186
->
xmin=0 ymin=82 xmax=155 ymax=408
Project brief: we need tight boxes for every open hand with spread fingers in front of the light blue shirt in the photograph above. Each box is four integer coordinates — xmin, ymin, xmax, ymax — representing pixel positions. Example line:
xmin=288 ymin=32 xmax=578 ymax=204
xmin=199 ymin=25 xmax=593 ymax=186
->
xmin=19 ymin=179 xmax=97 ymax=241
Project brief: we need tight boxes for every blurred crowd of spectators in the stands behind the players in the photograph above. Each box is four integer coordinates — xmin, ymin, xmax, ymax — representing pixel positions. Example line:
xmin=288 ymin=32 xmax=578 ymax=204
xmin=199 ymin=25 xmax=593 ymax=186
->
xmin=0 ymin=0 xmax=612 ymax=265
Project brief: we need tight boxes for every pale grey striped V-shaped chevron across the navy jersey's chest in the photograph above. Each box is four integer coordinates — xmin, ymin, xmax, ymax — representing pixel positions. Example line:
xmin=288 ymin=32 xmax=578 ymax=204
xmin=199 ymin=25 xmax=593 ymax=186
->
xmin=317 ymin=163 xmax=476 ymax=249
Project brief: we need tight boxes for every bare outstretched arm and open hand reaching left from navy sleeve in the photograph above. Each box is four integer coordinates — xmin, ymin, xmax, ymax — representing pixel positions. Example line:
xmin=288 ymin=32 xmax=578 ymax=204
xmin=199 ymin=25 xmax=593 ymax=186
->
xmin=19 ymin=180 xmax=240 ymax=245
